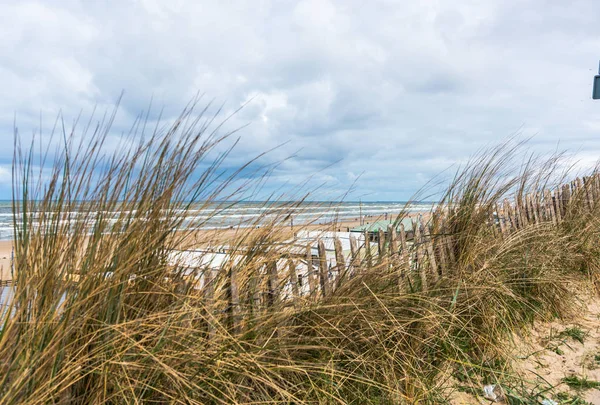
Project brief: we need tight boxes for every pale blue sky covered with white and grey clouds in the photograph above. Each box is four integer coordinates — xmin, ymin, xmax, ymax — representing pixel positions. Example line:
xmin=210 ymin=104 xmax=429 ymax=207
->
xmin=0 ymin=0 xmax=600 ymax=201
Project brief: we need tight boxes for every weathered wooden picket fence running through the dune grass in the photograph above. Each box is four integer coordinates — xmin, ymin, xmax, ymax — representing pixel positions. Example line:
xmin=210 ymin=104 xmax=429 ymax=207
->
xmin=183 ymin=175 xmax=600 ymax=332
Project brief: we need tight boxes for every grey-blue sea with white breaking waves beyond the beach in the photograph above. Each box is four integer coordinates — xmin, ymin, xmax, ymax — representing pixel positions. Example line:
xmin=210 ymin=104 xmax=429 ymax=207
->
xmin=0 ymin=200 xmax=433 ymax=240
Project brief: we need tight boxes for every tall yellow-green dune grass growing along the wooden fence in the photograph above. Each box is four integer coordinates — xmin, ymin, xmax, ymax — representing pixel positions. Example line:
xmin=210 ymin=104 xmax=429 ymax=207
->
xmin=0 ymin=105 xmax=600 ymax=404
